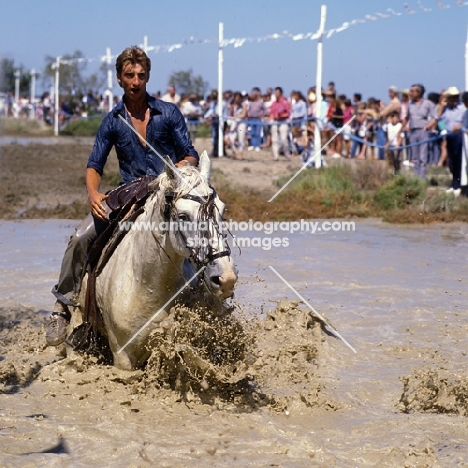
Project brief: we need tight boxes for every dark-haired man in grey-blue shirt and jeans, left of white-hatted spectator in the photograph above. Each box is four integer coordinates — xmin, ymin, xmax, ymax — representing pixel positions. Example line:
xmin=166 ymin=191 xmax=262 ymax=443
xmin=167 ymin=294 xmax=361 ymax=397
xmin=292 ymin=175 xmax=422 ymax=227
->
xmin=402 ymin=84 xmax=437 ymax=179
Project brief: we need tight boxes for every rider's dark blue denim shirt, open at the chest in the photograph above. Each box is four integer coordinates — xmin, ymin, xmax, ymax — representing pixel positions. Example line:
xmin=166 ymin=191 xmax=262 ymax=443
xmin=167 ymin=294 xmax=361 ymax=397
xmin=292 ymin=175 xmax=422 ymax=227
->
xmin=87 ymin=94 xmax=198 ymax=183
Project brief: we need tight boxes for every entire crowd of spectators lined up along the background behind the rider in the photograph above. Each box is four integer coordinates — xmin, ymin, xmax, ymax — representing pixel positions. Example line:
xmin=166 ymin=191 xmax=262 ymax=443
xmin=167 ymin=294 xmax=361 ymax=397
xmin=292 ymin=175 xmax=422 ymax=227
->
xmin=4 ymin=82 xmax=468 ymax=196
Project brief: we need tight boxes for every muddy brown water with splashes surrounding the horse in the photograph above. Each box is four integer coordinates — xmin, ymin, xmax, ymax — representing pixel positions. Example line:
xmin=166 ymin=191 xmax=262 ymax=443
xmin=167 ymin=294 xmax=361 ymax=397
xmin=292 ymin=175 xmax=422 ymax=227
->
xmin=0 ymin=220 xmax=468 ymax=467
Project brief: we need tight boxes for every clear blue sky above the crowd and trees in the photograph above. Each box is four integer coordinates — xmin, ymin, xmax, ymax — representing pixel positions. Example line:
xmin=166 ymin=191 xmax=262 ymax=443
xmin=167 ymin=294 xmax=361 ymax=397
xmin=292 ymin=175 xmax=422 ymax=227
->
xmin=0 ymin=0 xmax=468 ymax=100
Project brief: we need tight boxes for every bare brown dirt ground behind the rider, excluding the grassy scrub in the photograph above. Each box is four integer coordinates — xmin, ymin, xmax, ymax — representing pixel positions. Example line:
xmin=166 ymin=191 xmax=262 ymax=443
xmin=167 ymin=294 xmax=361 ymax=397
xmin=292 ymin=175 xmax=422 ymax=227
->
xmin=0 ymin=137 xmax=301 ymax=219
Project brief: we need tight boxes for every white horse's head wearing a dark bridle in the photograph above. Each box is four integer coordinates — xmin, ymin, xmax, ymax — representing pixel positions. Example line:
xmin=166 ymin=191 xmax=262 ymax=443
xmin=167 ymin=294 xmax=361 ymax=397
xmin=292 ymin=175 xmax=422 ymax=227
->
xmin=159 ymin=151 xmax=237 ymax=299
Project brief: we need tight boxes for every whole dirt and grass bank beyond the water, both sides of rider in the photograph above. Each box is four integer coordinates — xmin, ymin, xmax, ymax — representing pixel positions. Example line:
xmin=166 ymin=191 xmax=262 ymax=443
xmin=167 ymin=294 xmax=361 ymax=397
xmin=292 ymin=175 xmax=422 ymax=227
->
xmin=0 ymin=137 xmax=462 ymax=223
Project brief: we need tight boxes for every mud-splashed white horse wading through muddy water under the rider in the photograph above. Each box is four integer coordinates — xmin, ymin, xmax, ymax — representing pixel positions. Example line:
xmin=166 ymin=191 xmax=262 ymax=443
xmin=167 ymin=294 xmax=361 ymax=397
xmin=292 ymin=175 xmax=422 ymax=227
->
xmin=71 ymin=152 xmax=237 ymax=370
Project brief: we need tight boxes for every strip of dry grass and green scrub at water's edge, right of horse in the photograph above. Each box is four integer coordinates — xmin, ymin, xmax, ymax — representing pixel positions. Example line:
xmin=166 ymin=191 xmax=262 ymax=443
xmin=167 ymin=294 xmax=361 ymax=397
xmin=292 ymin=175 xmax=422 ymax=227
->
xmin=214 ymin=161 xmax=468 ymax=223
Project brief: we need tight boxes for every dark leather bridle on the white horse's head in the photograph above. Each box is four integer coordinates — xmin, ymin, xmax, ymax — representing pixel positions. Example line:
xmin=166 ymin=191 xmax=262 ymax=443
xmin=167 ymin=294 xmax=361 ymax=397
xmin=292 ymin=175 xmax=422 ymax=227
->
xmin=163 ymin=187 xmax=231 ymax=269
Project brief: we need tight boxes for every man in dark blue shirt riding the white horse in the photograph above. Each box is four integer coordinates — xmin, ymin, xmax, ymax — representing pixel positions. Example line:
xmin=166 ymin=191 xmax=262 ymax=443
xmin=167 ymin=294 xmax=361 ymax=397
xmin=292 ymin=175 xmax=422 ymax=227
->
xmin=46 ymin=46 xmax=199 ymax=346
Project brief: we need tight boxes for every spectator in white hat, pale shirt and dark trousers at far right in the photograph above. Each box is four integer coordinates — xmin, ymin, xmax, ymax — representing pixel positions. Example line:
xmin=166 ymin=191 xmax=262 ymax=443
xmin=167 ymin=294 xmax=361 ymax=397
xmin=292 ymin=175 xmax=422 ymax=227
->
xmin=440 ymin=86 xmax=466 ymax=197
